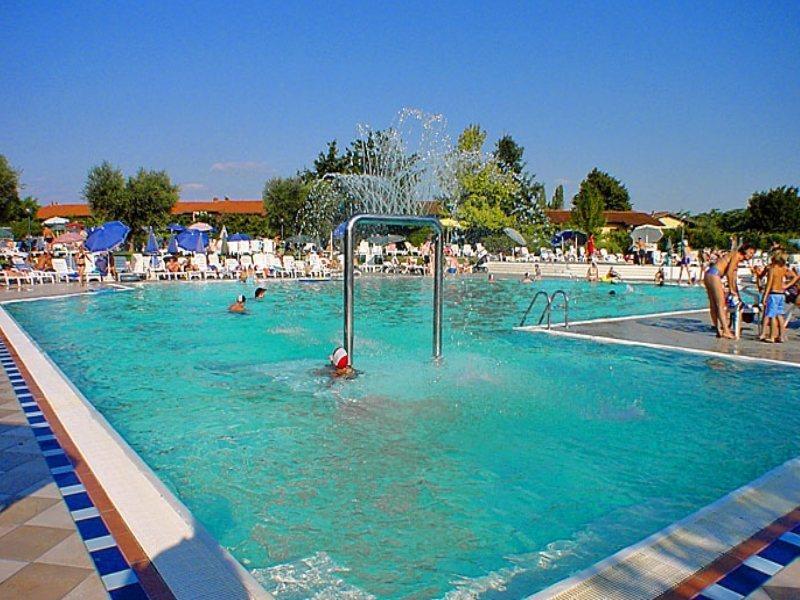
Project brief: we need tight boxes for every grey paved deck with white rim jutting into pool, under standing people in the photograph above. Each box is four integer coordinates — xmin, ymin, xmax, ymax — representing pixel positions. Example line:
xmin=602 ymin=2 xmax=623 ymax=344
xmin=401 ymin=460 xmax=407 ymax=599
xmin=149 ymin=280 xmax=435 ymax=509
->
xmin=517 ymin=310 xmax=800 ymax=367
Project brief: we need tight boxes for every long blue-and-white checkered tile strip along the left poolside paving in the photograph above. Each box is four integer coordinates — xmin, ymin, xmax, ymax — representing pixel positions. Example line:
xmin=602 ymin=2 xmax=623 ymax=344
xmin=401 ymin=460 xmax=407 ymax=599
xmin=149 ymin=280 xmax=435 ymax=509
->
xmin=0 ymin=340 xmax=147 ymax=600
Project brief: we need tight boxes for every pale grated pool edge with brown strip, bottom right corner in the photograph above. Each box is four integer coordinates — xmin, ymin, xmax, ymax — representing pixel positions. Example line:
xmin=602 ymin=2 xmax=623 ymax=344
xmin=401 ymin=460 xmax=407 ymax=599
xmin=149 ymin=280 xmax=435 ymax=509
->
xmin=528 ymin=457 xmax=800 ymax=600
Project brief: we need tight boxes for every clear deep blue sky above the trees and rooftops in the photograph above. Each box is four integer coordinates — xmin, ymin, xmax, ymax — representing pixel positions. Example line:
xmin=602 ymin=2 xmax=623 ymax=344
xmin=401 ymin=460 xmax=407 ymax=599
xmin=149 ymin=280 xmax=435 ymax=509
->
xmin=0 ymin=0 xmax=800 ymax=211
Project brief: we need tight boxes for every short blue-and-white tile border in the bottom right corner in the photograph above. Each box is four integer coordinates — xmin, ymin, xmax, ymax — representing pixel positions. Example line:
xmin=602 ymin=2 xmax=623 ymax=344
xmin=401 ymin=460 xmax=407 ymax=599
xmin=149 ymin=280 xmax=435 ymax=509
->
xmin=694 ymin=525 xmax=800 ymax=600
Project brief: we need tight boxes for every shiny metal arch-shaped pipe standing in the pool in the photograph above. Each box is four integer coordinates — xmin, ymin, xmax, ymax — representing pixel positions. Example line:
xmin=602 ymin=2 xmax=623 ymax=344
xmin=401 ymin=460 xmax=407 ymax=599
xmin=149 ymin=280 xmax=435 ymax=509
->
xmin=344 ymin=214 xmax=444 ymax=365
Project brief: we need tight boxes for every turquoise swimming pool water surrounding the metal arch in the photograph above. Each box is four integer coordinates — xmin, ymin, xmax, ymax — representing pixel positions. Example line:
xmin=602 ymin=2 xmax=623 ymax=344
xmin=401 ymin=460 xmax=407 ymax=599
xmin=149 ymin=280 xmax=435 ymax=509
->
xmin=6 ymin=278 xmax=800 ymax=599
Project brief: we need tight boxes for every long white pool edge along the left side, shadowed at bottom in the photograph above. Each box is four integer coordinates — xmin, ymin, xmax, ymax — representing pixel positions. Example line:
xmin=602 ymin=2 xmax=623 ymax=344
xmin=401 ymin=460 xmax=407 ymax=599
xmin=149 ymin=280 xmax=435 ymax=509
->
xmin=0 ymin=307 xmax=271 ymax=599
